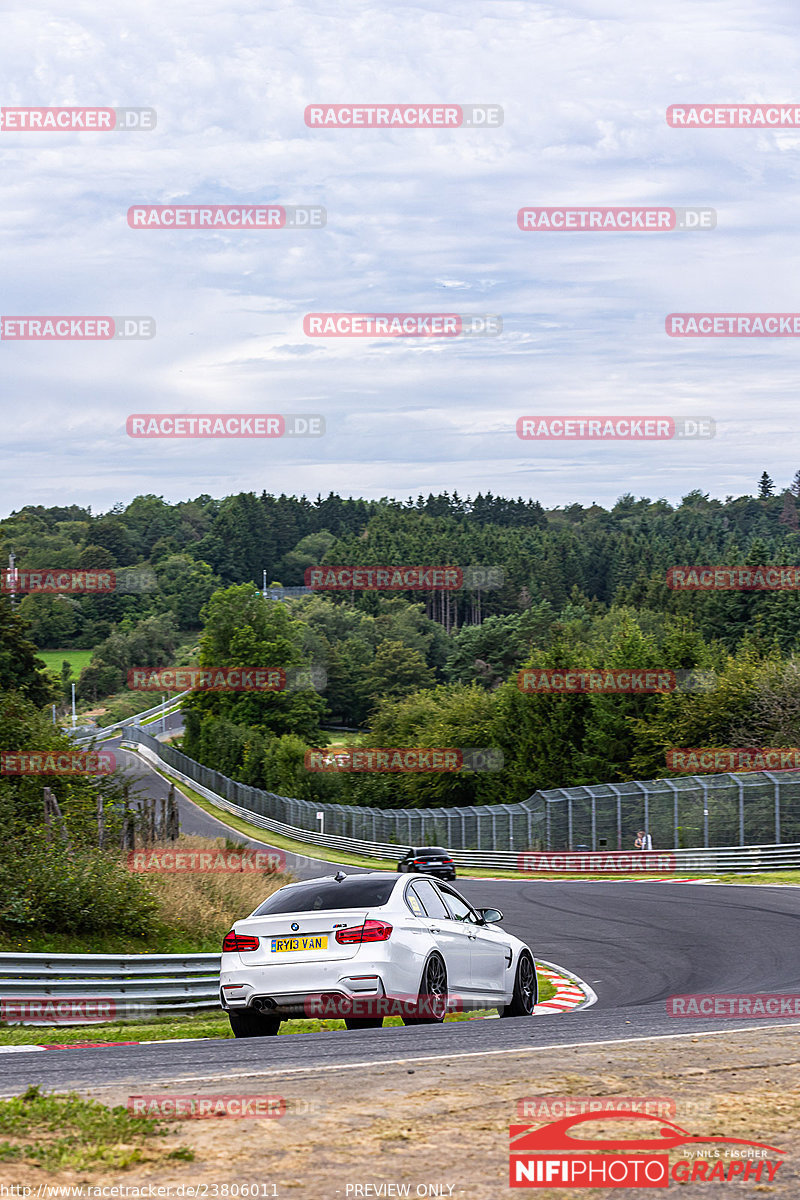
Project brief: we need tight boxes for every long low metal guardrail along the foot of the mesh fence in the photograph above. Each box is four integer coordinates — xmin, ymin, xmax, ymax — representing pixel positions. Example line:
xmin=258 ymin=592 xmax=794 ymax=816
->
xmin=128 ymin=731 xmax=800 ymax=875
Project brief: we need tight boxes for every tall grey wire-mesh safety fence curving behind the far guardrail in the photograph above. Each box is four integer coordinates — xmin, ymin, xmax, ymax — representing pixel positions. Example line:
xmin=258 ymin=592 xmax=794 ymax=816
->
xmin=123 ymin=727 xmax=800 ymax=854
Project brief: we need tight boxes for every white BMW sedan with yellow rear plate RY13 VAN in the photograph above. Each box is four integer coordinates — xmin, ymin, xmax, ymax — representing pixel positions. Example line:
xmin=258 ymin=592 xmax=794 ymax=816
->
xmin=219 ymin=871 xmax=537 ymax=1038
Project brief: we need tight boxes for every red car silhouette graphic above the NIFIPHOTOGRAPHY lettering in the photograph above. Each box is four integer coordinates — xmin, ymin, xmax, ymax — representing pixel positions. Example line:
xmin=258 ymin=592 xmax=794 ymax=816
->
xmin=509 ymin=1109 xmax=783 ymax=1154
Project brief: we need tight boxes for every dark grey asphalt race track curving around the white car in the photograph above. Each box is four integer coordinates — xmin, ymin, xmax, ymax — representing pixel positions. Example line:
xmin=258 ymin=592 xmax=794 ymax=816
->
xmin=0 ymin=756 xmax=800 ymax=1096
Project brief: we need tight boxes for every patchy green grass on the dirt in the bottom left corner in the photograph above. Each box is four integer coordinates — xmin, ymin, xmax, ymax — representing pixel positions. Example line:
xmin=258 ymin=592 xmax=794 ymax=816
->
xmin=0 ymin=1087 xmax=194 ymax=1171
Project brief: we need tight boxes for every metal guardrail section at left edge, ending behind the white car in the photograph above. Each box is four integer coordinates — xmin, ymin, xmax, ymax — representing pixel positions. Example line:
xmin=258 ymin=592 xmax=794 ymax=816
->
xmin=0 ymin=953 xmax=219 ymax=1024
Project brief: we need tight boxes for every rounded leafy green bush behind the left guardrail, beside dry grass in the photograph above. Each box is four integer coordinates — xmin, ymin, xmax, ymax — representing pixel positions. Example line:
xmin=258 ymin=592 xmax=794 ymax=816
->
xmin=0 ymin=845 xmax=157 ymax=936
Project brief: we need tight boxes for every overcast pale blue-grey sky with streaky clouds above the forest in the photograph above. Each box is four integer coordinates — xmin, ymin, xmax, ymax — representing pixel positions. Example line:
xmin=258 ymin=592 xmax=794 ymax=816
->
xmin=0 ymin=0 xmax=800 ymax=515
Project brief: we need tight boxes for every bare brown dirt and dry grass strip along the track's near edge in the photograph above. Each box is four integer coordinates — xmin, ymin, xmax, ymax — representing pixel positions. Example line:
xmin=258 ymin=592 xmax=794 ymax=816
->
xmin=0 ymin=1027 xmax=800 ymax=1200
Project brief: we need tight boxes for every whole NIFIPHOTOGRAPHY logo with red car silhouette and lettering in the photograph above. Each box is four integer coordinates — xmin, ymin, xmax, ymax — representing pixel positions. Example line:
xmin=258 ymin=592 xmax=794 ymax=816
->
xmin=509 ymin=1108 xmax=783 ymax=1188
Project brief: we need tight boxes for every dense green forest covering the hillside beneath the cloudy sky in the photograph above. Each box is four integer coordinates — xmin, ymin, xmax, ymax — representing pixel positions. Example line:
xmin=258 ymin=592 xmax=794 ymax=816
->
xmin=0 ymin=473 xmax=800 ymax=806
